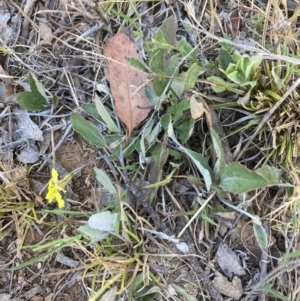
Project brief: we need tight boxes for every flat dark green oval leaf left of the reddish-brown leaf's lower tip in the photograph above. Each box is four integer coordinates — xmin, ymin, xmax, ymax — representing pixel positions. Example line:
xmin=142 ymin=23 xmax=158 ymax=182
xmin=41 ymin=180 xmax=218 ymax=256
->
xmin=71 ymin=113 xmax=106 ymax=147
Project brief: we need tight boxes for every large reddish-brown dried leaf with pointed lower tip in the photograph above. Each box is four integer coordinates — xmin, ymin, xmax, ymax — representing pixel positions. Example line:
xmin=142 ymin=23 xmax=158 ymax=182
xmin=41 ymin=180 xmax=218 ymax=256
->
xmin=104 ymin=32 xmax=150 ymax=137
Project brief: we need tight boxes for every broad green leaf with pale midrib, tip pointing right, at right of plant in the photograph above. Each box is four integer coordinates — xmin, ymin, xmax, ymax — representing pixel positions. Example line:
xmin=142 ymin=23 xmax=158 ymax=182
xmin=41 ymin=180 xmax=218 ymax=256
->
xmin=218 ymin=162 xmax=268 ymax=193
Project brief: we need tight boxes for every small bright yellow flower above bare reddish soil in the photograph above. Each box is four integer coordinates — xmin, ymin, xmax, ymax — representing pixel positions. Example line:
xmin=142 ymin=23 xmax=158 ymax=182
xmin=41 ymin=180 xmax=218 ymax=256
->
xmin=46 ymin=168 xmax=67 ymax=208
